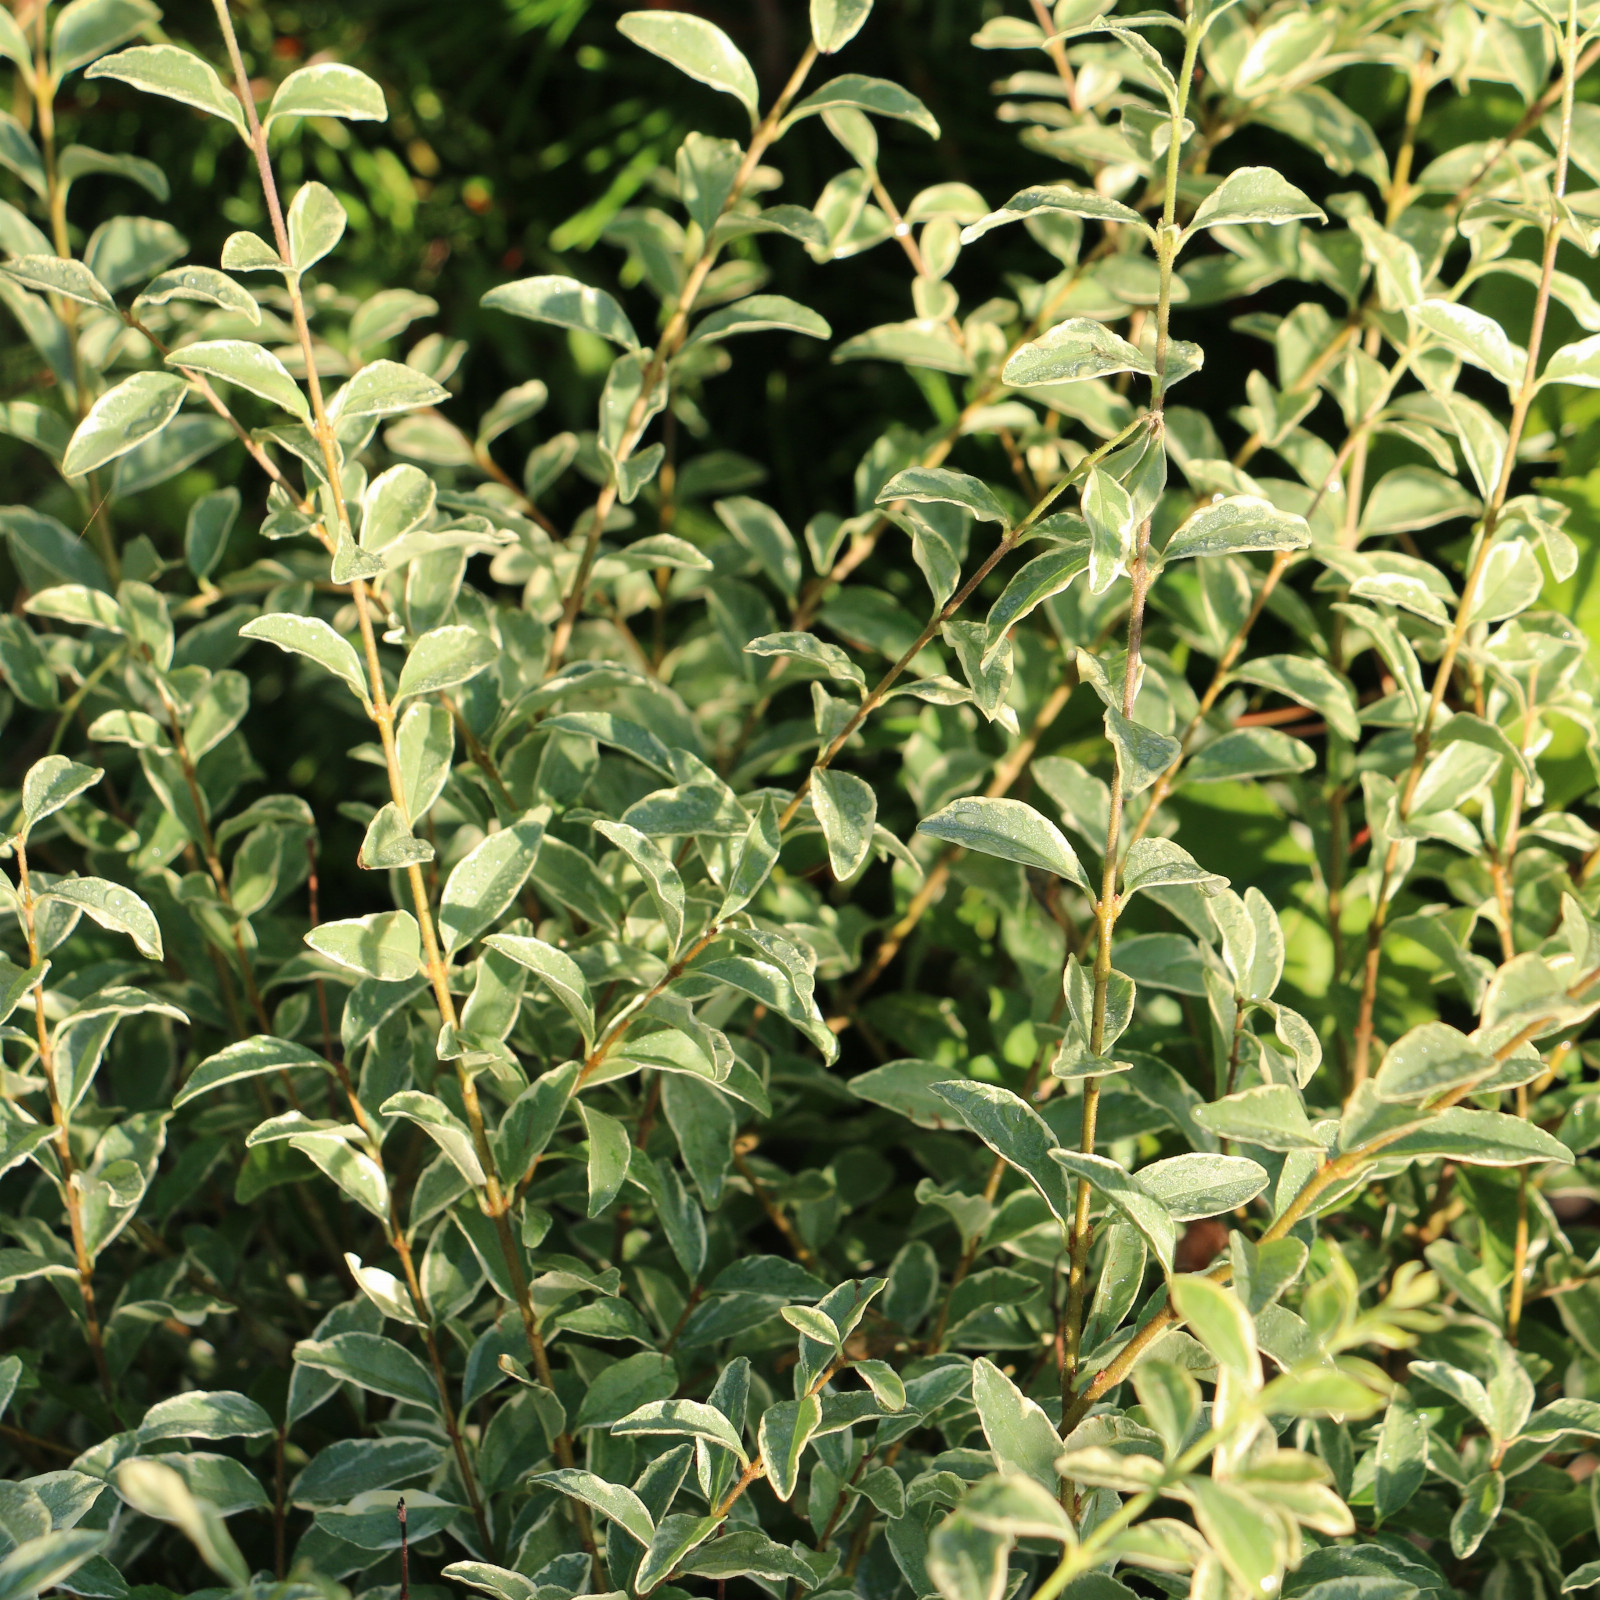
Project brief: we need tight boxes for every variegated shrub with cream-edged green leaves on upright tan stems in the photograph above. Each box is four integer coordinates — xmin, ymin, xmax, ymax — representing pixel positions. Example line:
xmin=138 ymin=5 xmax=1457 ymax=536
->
xmin=0 ymin=0 xmax=1600 ymax=1600
